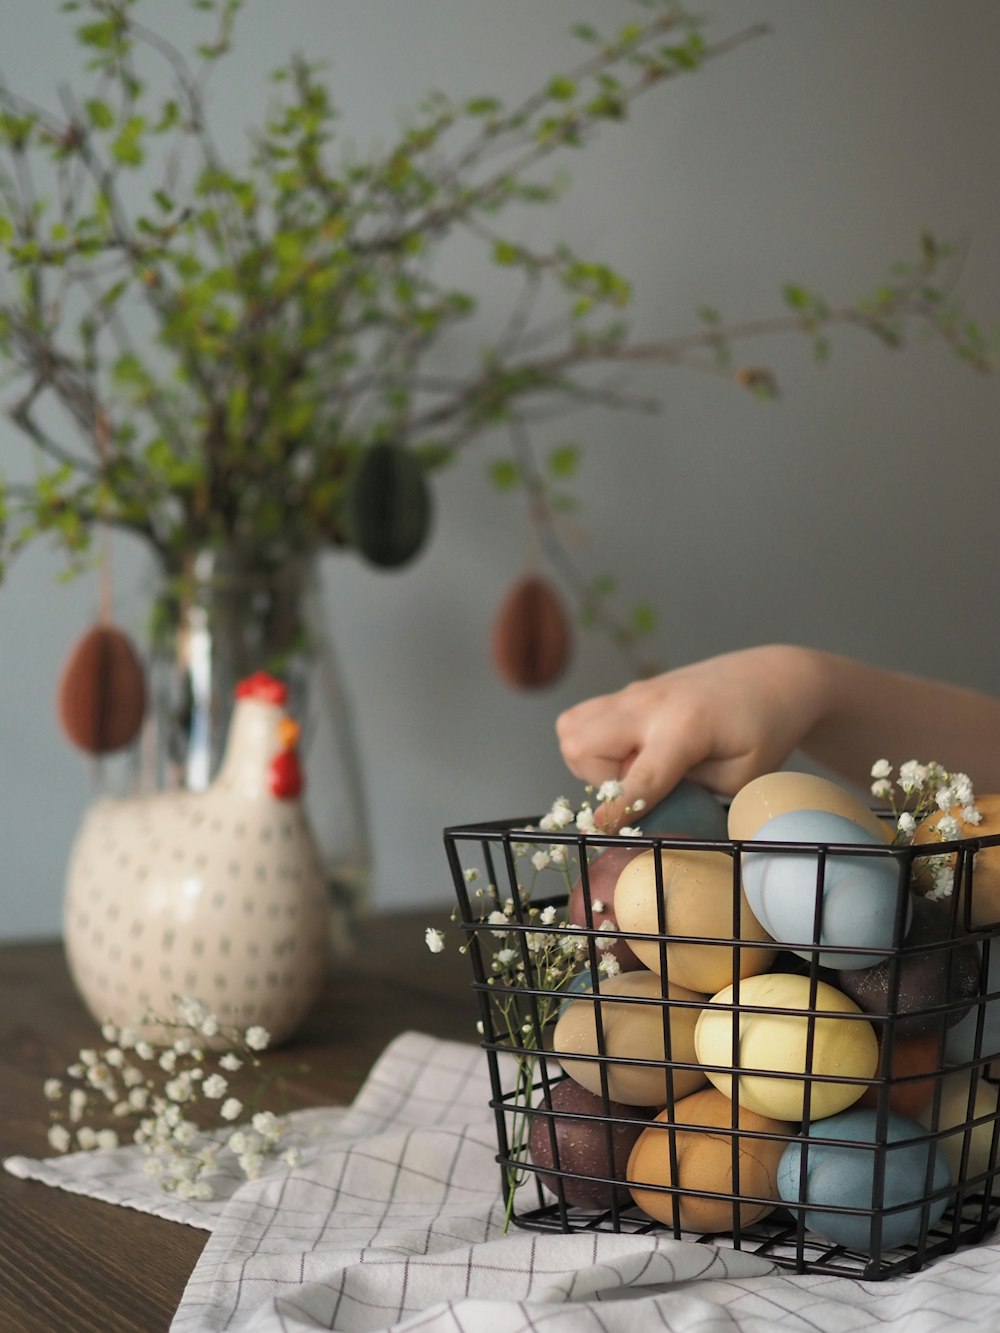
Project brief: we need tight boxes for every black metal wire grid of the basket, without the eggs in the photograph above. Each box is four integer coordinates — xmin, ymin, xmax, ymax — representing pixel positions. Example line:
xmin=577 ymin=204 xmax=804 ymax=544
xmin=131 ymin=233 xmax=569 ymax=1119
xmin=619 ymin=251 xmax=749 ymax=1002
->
xmin=444 ymin=818 xmax=1000 ymax=1280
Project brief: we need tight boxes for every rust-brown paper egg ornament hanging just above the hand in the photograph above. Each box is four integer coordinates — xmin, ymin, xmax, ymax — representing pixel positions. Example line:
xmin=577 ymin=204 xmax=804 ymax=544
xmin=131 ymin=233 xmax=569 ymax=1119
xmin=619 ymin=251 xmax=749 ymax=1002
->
xmin=489 ymin=575 xmax=572 ymax=689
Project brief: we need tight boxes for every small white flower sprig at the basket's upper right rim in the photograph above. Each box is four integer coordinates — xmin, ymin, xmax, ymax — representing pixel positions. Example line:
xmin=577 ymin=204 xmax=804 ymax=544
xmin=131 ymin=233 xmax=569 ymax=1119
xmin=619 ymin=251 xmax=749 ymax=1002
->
xmin=871 ymin=758 xmax=983 ymax=900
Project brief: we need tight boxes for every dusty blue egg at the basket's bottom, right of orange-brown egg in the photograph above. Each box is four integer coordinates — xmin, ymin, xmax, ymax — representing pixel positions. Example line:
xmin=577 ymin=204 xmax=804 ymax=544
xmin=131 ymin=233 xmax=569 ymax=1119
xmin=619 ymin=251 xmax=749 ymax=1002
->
xmin=777 ymin=1110 xmax=952 ymax=1253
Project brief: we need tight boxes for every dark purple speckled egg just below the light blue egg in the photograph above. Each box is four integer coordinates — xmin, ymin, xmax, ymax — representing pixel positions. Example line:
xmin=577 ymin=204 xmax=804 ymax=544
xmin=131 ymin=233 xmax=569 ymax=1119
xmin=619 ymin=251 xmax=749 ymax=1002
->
xmin=836 ymin=896 xmax=979 ymax=1037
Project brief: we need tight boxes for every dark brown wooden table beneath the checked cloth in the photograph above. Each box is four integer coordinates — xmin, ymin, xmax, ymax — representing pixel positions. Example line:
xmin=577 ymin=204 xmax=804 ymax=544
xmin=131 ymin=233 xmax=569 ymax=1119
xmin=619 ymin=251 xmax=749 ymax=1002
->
xmin=0 ymin=910 xmax=477 ymax=1333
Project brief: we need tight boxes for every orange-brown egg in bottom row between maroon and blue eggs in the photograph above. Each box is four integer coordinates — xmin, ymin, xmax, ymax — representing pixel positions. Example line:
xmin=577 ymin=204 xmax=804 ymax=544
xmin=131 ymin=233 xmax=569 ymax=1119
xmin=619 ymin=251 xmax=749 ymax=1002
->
xmin=628 ymin=1088 xmax=795 ymax=1233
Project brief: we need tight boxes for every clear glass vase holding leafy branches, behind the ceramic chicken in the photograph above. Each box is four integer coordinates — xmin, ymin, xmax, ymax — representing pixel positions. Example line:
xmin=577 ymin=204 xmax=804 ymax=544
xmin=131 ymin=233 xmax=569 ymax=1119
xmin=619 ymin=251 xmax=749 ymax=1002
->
xmin=140 ymin=548 xmax=371 ymax=957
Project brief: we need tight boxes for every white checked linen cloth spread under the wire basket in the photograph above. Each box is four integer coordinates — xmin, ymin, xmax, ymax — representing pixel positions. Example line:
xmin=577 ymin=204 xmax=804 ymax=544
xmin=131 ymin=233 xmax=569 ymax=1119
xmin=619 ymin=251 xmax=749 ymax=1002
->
xmin=5 ymin=1033 xmax=1000 ymax=1333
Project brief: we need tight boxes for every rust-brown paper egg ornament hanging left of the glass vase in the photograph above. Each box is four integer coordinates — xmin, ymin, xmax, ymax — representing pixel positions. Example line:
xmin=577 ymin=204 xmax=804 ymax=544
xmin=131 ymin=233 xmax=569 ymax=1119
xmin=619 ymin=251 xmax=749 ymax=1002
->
xmin=57 ymin=624 xmax=145 ymax=754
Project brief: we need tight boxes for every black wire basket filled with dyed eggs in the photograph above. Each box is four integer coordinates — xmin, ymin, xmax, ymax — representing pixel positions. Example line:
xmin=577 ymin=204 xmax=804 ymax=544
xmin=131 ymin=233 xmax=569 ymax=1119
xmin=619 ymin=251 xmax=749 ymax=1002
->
xmin=444 ymin=820 xmax=1000 ymax=1280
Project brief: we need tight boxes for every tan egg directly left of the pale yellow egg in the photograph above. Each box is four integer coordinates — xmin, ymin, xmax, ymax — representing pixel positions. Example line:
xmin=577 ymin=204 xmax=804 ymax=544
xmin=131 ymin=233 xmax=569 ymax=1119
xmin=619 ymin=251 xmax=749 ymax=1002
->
xmin=552 ymin=972 xmax=707 ymax=1106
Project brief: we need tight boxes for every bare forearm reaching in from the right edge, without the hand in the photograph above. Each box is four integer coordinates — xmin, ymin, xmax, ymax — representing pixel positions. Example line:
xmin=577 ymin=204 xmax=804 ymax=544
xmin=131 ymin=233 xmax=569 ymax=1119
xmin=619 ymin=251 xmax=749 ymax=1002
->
xmin=800 ymin=649 xmax=1000 ymax=792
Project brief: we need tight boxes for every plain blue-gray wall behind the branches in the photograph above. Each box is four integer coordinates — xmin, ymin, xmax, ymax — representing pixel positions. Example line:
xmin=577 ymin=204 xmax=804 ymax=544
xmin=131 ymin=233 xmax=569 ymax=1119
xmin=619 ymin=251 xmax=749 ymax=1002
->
xmin=0 ymin=0 xmax=1000 ymax=937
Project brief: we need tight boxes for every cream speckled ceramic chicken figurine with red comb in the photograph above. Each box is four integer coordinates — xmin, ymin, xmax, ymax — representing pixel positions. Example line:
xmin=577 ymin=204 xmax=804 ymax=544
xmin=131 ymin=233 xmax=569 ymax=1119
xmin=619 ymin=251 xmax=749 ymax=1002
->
xmin=64 ymin=673 xmax=328 ymax=1044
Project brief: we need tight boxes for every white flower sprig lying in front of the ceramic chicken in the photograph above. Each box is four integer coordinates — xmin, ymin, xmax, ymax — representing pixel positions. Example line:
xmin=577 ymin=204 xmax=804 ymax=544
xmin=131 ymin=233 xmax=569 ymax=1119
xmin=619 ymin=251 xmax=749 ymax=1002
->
xmin=43 ymin=996 xmax=299 ymax=1200
